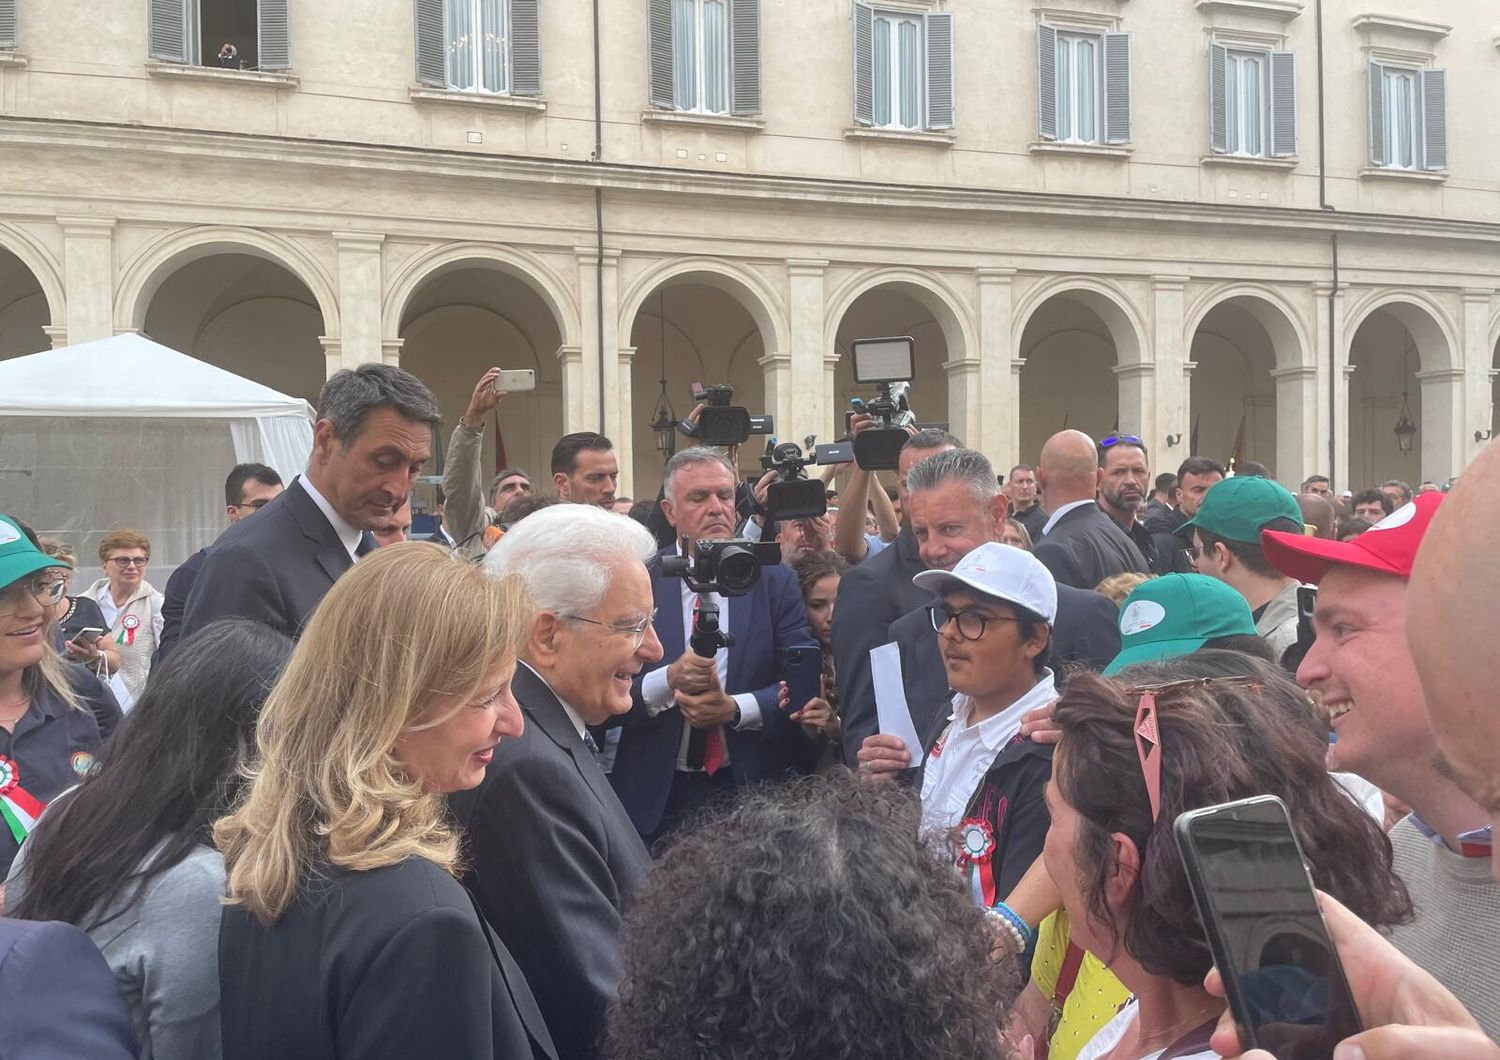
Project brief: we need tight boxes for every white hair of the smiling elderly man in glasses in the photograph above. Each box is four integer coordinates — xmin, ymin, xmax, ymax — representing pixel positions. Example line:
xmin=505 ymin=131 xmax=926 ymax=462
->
xmin=485 ymin=504 xmax=657 ymax=615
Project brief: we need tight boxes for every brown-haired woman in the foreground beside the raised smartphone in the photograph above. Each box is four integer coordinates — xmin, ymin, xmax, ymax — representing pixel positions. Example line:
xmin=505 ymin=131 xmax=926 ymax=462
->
xmin=1044 ymin=651 xmax=1412 ymax=1060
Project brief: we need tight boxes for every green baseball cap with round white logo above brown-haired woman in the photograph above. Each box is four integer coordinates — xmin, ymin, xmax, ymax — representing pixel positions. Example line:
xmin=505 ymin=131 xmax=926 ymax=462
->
xmin=1104 ymin=575 xmax=1256 ymax=678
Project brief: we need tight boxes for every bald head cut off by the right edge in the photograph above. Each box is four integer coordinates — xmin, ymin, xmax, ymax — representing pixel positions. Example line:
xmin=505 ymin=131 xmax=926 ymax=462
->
xmin=1407 ymin=442 xmax=1500 ymax=887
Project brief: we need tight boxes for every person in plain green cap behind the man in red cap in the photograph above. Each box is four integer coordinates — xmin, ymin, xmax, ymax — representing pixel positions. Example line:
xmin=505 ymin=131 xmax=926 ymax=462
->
xmin=1184 ymin=475 xmax=1302 ymax=663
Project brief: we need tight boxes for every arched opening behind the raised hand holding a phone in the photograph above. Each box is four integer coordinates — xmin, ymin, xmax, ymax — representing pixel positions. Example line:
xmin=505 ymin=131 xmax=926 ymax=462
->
xmin=399 ymin=261 xmax=566 ymax=500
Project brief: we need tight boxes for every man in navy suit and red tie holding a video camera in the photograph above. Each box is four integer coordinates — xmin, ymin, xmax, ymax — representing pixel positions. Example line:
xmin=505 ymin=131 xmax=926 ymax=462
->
xmin=609 ymin=447 xmax=816 ymax=844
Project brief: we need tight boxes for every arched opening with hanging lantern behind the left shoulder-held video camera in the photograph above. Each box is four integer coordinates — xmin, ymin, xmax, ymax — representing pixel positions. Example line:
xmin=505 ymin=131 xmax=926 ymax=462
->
xmin=630 ymin=274 xmax=762 ymax=499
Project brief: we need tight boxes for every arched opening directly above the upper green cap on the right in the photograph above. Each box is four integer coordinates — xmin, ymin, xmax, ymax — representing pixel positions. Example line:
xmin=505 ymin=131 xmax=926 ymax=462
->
xmin=1187 ymin=297 xmax=1277 ymax=477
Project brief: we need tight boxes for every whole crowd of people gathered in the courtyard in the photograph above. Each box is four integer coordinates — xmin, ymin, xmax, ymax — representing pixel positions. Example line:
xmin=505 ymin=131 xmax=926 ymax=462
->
xmin=0 ymin=364 xmax=1500 ymax=1060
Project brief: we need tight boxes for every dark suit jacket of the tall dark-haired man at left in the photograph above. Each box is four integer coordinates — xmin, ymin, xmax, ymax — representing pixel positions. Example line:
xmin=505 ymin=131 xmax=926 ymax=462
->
xmin=182 ymin=477 xmax=354 ymax=647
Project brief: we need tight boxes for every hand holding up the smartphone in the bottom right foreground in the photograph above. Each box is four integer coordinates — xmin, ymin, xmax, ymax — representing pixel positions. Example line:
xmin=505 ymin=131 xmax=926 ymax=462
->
xmin=1203 ymin=891 xmax=1500 ymax=1060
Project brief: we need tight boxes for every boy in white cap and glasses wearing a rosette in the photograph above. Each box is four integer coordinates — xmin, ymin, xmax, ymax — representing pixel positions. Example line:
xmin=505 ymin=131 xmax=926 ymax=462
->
xmin=858 ymin=541 xmax=1058 ymax=923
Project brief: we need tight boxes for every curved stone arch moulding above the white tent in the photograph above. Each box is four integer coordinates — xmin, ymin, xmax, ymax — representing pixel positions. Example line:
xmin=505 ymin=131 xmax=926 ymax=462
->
xmin=114 ymin=225 xmax=339 ymax=336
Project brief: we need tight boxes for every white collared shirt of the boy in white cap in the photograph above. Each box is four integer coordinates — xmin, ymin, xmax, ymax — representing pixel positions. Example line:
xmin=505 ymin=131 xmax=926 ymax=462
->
xmin=923 ymin=670 xmax=1058 ymax=834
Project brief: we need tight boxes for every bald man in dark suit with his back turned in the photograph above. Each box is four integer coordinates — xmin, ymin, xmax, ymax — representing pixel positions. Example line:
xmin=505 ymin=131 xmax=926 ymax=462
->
xmin=1035 ymin=430 xmax=1151 ymax=589
